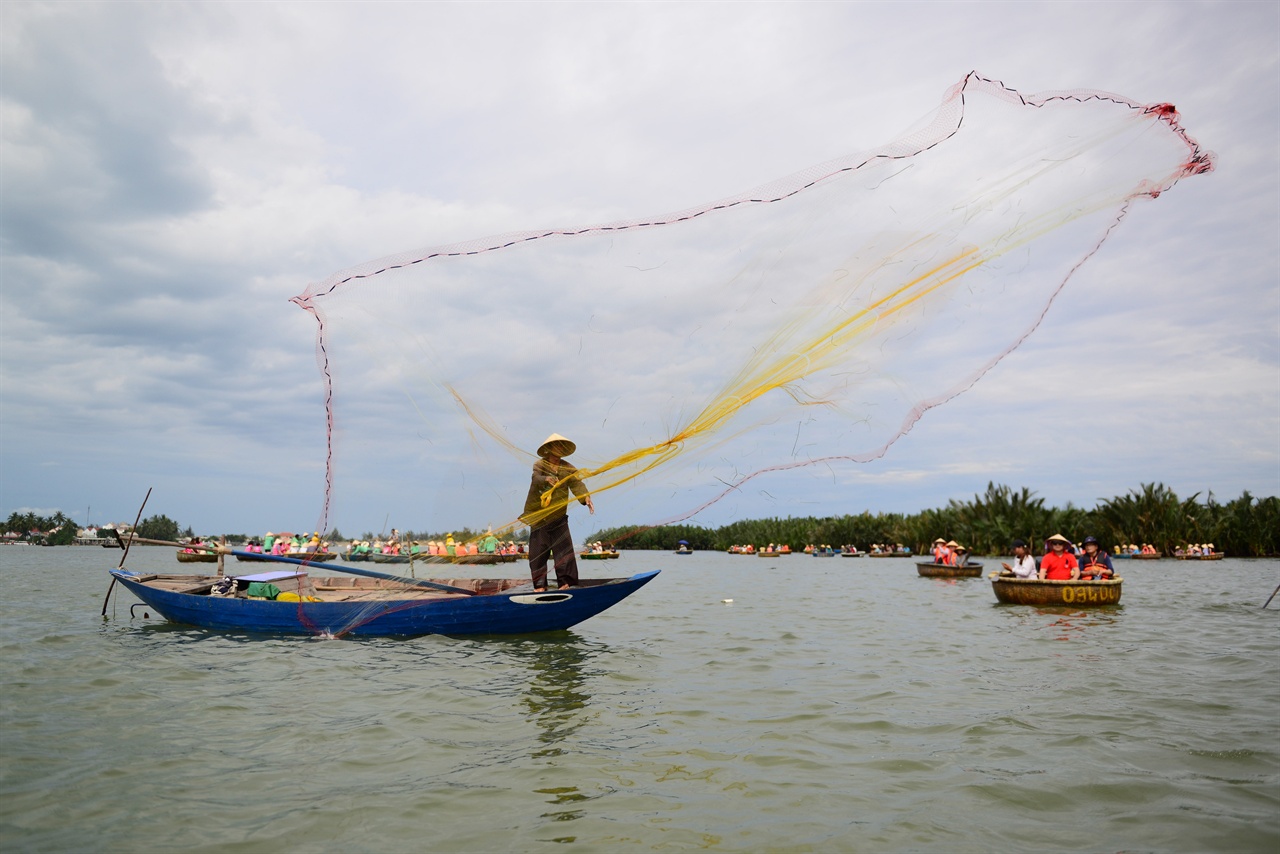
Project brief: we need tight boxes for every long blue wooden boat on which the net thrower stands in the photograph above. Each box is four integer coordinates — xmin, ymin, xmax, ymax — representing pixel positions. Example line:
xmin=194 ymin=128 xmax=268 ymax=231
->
xmin=104 ymin=567 xmax=658 ymax=638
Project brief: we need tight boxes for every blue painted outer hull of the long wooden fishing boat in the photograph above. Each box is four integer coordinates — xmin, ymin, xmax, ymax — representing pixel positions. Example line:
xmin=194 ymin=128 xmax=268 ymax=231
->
xmin=111 ymin=570 xmax=658 ymax=638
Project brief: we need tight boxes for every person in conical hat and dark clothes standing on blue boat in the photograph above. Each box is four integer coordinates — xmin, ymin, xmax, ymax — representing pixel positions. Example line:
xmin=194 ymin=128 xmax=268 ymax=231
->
xmin=520 ymin=433 xmax=595 ymax=592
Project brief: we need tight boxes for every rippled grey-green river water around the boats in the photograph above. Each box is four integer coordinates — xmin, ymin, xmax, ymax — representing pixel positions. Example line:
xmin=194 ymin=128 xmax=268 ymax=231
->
xmin=0 ymin=547 xmax=1280 ymax=854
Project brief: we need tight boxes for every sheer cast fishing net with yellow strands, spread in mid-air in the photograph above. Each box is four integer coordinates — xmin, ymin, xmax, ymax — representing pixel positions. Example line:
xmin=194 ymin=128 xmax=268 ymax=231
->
xmin=293 ymin=74 xmax=1212 ymax=540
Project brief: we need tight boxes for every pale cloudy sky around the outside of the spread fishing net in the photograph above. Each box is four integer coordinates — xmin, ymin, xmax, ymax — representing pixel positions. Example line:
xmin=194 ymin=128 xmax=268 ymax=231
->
xmin=0 ymin=3 xmax=1280 ymax=533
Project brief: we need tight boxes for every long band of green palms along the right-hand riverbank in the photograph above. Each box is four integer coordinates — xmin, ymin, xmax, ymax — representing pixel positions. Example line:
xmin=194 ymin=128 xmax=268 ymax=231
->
xmin=588 ymin=483 xmax=1280 ymax=557
